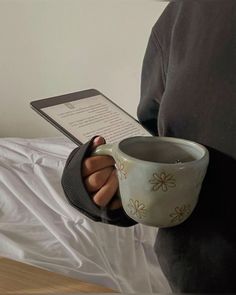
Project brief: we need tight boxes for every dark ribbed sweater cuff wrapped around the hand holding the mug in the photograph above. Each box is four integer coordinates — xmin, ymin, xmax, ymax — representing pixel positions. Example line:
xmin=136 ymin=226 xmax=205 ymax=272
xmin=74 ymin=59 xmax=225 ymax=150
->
xmin=61 ymin=138 xmax=136 ymax=227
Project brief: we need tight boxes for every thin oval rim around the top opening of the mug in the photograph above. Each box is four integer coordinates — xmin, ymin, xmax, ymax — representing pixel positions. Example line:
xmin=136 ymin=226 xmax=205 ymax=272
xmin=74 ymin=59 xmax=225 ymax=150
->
xmin=118 ymin=136 xmax=209 ymax=167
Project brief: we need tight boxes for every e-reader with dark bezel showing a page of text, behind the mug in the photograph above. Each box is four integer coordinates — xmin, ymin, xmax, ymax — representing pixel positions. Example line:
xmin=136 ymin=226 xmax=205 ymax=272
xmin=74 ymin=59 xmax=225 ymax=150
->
xmin=31 ymin=91 xmax=150 ymax=143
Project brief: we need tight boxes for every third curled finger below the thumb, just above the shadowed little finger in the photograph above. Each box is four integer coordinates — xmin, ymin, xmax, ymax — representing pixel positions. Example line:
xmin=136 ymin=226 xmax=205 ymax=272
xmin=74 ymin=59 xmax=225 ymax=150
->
xmin=93 ymin=169 xmax=118 ymax=207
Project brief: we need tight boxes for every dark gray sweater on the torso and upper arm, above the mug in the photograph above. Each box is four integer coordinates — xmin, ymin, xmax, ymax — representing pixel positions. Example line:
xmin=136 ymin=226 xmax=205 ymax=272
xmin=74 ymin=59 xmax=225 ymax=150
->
xmin=138 ymin=0 xmax=236 ymax=159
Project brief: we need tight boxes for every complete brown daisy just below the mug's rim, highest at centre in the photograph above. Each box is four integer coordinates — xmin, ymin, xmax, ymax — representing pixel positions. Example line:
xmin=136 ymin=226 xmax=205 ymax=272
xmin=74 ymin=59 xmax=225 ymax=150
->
xmin=149 ymin=171 xmax=176 ymax=192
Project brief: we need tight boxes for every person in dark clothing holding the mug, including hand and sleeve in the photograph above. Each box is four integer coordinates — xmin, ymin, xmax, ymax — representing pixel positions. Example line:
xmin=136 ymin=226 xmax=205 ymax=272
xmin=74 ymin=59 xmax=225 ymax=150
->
xmin=62 ymin=0 xmax=236 ymax=293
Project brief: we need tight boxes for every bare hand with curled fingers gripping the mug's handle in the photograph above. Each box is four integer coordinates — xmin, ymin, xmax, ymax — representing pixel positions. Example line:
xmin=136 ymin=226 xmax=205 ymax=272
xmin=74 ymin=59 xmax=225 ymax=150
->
xmin=82 ymin=137 xmax=122 ymax=209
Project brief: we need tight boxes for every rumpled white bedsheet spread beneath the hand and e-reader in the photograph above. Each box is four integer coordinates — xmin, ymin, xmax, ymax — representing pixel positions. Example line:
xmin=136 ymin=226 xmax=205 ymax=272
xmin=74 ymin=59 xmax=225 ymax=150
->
xmin=0 ymin=137 xmax=170 ymax=293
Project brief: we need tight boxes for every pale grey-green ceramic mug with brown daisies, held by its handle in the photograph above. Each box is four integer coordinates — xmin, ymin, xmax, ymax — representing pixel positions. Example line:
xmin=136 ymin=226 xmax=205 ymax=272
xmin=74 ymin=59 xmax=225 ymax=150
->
xmin=93 ymin=136 xmax=209 ymax=227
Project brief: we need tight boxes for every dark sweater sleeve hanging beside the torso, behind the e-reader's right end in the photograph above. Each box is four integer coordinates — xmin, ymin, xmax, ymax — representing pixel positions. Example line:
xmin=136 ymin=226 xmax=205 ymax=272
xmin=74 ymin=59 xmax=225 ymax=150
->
xmin=137 ymin=29 xmax=165 ymax=135
